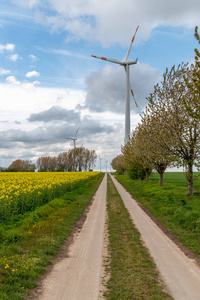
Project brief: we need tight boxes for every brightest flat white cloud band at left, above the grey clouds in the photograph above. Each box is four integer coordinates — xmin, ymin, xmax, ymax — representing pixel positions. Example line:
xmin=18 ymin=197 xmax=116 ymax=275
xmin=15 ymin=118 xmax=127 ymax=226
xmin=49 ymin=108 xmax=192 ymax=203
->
xmin=0 ymin=84 xmax=85 ymax=119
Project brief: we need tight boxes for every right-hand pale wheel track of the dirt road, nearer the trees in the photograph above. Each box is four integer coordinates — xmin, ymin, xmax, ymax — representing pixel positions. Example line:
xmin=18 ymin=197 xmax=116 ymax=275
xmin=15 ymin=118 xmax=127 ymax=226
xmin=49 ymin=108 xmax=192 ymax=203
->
xmin=112 ymin=176 xmax=200 ymax=300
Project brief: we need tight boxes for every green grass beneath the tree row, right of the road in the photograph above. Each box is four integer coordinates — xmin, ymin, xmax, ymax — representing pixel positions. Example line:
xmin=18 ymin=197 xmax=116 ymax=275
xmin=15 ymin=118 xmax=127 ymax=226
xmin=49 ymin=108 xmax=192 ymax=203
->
xmin=116 ymin=172 xmax=200 ymax=258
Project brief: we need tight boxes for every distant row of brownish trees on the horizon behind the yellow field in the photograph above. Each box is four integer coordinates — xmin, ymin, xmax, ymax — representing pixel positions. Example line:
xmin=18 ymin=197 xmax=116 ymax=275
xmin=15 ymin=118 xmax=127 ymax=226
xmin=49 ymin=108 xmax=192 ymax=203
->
xmin=0 ymin=147 xmax=97 ymax=172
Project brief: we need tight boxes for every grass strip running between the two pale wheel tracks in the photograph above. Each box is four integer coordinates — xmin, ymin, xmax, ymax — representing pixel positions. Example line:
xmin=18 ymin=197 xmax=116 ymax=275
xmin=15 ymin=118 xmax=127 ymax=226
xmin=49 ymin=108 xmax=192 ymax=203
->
xmin=105 ymin=176 xmax=172 ymax=300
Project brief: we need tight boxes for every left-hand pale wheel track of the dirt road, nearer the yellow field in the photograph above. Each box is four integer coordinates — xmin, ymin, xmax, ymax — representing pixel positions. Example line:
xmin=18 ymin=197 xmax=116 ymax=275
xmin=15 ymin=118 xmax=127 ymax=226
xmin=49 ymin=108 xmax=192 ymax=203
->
xmin=38 ymin=175 xmax=107 ymax=300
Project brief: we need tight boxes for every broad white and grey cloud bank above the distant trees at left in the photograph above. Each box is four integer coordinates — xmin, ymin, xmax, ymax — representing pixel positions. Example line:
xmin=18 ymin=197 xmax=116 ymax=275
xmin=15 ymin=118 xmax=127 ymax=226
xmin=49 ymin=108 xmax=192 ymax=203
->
xmin=0 ymin=82 xmax=119 ymax=166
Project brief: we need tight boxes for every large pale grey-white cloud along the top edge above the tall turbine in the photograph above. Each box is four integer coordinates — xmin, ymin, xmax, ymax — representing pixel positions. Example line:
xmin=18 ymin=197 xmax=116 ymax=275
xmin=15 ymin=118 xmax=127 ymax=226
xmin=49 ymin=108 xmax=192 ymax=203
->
xmin=30 ymin=0 xmax=200 ymax=46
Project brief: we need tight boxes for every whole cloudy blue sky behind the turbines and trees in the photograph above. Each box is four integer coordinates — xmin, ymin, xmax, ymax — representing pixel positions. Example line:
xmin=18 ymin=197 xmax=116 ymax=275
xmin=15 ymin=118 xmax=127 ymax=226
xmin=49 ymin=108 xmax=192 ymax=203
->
xmin=0 ymin=0 xmax=200 ymax=170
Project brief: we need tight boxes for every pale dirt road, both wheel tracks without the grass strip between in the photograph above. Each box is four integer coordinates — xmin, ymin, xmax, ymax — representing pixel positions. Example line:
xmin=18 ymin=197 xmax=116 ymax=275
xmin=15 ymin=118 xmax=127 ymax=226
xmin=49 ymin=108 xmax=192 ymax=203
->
xmin=31 ymin=175 xmax=200 ymax=300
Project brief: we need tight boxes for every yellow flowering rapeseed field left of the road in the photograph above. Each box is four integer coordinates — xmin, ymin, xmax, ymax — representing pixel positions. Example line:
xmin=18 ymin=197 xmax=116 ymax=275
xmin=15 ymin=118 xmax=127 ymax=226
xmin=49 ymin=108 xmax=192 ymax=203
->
xmin=0 ymin=172 xmax=99 ymax=221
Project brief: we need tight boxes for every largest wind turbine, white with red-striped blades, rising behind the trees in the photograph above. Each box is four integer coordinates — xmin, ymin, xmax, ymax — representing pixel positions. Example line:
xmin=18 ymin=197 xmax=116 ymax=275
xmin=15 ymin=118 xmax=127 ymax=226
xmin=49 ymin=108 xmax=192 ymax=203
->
xmin=92 ymin=26 xmax=139 ymax=143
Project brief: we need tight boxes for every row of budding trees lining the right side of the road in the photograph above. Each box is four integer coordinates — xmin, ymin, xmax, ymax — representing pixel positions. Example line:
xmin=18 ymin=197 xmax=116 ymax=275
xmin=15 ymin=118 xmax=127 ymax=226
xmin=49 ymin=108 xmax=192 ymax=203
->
xmin=112 ymin=27 xmax=200 ymax=195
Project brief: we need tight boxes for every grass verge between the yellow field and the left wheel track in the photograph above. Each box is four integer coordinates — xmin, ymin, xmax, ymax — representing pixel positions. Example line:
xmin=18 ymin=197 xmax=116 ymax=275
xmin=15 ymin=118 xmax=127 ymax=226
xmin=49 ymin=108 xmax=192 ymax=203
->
xmin=0 ymin=173 xmax=104 ymax=300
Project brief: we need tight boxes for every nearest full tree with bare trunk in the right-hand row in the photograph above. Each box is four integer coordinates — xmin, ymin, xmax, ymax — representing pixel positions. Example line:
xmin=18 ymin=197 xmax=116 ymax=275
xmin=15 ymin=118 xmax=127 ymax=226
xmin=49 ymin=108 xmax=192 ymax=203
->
xmin=147 ymin=64 xmax=200 ymax=195
